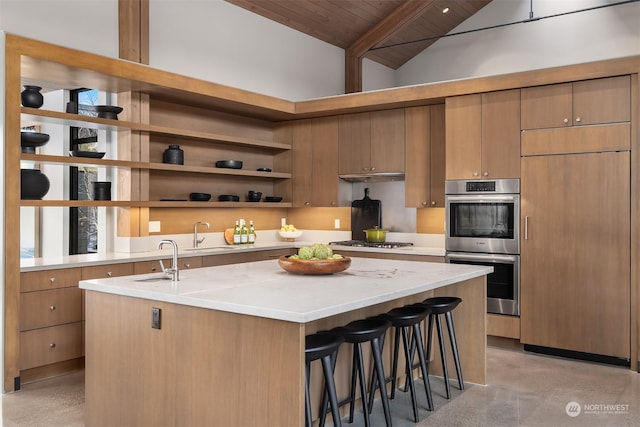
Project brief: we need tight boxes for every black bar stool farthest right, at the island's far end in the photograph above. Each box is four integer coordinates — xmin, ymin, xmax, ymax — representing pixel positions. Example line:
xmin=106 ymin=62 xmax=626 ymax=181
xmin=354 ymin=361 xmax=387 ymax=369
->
xmin=421 ymin=297 xmax=464 ymax=399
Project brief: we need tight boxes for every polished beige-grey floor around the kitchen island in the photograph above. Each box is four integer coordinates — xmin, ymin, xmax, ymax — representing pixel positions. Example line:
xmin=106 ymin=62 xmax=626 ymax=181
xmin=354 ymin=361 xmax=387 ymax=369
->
xmin=1 ymin=340 xmax=640 ymax=427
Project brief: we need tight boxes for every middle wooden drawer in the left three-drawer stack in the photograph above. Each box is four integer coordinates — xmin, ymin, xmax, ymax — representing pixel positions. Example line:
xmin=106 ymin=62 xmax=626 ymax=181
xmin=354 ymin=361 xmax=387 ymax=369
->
xmin=20 ymin=287 xmax=82 ymax=331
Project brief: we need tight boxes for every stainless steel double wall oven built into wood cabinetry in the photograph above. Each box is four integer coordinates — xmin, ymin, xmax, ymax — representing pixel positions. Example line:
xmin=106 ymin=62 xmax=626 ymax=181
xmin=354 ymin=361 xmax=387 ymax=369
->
xmin=445 ymin=179 xmax=520 ymax=316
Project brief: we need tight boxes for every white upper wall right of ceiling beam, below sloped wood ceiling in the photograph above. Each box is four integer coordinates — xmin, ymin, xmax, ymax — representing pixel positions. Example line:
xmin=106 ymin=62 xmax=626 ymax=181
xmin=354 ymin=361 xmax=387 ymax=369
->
xmin=396 ymin=0 xmax=640 ymax=86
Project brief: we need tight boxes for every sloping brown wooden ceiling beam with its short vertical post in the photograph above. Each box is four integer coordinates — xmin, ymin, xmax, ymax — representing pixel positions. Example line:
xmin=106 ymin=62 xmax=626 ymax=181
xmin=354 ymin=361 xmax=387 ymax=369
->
xmin=344 ymin=0 xmax=436 ymax=93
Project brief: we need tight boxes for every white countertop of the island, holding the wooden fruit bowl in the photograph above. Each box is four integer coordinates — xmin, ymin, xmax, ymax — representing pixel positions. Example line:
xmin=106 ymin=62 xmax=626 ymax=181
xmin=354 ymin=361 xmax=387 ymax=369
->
xmin=80 ymin=258 xmax=493 ymax=323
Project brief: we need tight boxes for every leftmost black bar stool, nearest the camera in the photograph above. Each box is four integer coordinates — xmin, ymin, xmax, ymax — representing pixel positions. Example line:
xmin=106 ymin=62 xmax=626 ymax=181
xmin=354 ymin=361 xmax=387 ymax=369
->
xmin=304 ymin=333 xmax=344 ymax=427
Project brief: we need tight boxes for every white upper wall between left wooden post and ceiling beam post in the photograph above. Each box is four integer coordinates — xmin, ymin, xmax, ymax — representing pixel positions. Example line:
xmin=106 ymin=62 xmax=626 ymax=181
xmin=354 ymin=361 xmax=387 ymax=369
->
xmin=149 ymin=0 xmax=344 ymax=100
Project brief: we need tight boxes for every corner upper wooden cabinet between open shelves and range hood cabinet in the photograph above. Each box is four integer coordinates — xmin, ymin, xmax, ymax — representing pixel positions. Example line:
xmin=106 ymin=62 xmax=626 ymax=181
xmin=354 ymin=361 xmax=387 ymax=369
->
xmin=292 ymin=117 xmax=339 ymax=207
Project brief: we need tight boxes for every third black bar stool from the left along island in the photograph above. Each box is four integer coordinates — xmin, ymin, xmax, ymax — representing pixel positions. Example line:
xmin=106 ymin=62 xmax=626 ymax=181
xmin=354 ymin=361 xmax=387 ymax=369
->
xmin=369 ymin=305 xmax=433 ymax=423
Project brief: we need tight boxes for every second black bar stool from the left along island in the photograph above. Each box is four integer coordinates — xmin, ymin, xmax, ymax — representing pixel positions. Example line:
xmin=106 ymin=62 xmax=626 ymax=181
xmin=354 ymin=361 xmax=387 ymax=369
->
xmin=319 ymin=318 xmax=391 ymax=427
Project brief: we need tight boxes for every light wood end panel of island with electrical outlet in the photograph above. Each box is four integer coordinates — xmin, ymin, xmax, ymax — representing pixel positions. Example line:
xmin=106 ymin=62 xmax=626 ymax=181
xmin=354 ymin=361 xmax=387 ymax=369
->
xmin=85 ymin=291 xmax=304 ymax=426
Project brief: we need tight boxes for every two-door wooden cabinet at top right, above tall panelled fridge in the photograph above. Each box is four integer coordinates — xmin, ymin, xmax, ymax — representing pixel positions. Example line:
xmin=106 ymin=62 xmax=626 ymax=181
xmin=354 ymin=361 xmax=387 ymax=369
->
xmin=522 ymin=76 xmax=631 ymax=130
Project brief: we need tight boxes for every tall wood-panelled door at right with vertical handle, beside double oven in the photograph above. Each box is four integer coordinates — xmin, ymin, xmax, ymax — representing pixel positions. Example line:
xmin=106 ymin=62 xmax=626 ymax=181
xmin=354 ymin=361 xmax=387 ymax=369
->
xmin=521 ymin=151 xmax=631 ymax=360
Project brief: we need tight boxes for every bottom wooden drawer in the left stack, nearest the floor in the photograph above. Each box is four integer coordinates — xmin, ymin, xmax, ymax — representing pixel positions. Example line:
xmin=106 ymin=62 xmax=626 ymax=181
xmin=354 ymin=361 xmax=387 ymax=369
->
xmin=20 ymin=322 xmax=82 ymax=369
